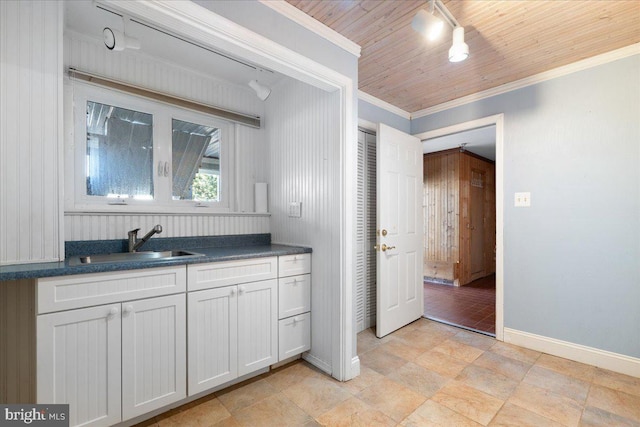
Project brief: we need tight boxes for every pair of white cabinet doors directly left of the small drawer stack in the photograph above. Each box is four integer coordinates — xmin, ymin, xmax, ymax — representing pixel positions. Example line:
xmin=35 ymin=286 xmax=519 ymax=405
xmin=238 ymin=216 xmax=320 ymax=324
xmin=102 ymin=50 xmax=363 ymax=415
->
xmin=188 ymin=280 xmax=278 ymax=395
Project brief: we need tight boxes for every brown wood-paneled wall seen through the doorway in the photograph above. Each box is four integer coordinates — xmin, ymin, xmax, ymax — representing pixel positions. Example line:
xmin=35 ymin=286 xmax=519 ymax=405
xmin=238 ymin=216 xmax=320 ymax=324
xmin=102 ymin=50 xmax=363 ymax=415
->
xmin=423 ymin=149 xmax=496 ymax=285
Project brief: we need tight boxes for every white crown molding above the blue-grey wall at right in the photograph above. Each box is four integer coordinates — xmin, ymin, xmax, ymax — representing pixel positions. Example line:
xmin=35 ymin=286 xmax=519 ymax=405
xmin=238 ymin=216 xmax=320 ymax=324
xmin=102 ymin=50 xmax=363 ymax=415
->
xmin=411 ymin=43 xmax=640 ymax=119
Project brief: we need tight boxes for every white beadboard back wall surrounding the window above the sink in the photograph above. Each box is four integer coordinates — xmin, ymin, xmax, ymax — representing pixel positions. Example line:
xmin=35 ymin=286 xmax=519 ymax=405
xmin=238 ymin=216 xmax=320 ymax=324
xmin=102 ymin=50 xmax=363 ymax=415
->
xmin=64 ymin=32 xmax=269 ymax=244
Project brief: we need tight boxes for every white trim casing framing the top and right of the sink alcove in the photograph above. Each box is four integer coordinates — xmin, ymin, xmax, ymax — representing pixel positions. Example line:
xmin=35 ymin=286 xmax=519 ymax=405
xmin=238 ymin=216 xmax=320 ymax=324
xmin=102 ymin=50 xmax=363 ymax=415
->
xmin=97 ymin=0 xmax=360 ymax=381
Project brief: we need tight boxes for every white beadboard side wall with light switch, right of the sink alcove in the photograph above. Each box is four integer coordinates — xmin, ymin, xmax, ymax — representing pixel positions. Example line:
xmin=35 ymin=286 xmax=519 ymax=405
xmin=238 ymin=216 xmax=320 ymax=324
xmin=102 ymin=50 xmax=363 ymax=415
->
xmin=266 ymin=81 xmax=341 ymax=372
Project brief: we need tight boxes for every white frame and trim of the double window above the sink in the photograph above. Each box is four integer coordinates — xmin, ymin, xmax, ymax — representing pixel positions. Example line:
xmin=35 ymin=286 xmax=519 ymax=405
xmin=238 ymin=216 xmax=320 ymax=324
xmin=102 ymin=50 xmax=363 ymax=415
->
xmin=65 ymin=80 xmax=236 ymax=214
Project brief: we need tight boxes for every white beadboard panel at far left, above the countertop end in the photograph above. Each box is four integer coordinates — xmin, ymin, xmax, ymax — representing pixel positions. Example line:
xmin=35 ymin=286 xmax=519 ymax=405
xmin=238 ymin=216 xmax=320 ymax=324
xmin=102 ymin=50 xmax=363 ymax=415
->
xmin=0 ymin=1 xmax=63 ymax=265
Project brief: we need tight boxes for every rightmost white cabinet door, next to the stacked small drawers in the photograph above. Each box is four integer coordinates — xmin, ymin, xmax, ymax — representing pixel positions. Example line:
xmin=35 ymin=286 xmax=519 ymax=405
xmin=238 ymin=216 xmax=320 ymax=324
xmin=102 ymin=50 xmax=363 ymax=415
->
xmin=238 ymin=279 xmax=278 ymax=376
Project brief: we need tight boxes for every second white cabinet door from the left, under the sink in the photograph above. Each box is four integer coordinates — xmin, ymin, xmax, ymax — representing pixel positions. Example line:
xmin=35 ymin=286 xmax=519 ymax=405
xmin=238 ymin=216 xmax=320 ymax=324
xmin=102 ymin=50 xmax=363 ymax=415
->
xmin=122 ymin=294 xmax=187 ymax=420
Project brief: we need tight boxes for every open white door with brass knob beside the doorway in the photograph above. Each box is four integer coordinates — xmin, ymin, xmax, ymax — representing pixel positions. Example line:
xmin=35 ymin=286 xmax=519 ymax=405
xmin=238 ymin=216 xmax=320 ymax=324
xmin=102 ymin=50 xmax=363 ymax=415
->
xmin=376 ymin=124 xmax=424 ymax=337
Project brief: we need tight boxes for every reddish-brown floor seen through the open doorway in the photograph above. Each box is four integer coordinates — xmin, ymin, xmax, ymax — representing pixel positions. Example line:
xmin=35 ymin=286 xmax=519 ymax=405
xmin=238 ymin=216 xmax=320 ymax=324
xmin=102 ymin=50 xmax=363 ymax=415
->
xmin=424 ymin=275 xmax=496 ymax=336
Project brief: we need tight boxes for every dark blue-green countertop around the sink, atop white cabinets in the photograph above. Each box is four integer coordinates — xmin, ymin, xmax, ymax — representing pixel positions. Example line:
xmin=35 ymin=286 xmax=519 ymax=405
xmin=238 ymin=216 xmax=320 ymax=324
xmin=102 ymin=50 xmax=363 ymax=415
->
xmin=0 ymin=236 xmax=312 ymax=281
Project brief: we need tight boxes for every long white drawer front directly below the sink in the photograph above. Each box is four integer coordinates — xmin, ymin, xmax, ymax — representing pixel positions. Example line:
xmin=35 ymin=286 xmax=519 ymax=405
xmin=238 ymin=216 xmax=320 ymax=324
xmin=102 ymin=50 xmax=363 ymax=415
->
xmin=36 ymin=266 xmax=187 ymax=314
